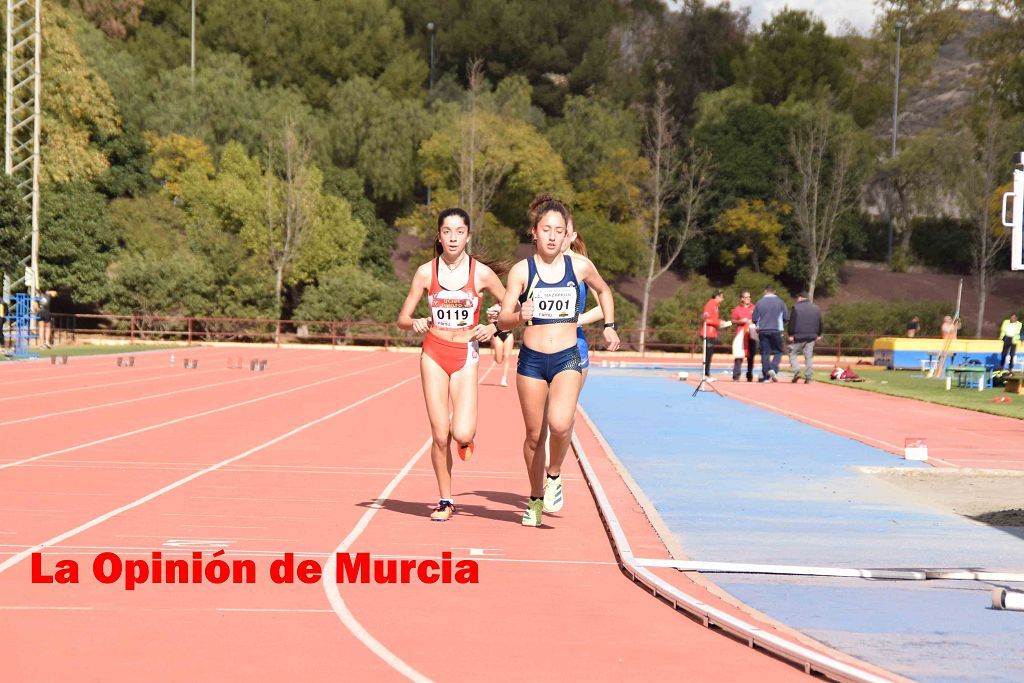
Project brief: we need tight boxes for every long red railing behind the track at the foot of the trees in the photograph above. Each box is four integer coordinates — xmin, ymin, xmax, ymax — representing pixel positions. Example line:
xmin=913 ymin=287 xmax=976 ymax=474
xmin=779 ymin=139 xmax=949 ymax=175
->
xmin=52 ymin=314 xmax=877 ymax=356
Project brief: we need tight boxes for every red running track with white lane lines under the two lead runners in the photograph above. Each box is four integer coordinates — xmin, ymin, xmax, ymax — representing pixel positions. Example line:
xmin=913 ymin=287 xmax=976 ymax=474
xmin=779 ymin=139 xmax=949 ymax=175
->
xmin=0 ymin=349 xmax=856 ymax=681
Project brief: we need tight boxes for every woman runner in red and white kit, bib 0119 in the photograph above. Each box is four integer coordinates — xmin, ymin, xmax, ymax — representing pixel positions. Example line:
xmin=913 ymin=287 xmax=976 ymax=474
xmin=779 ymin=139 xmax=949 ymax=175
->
xmin=398 ymin=209 xmax=505 ymax=521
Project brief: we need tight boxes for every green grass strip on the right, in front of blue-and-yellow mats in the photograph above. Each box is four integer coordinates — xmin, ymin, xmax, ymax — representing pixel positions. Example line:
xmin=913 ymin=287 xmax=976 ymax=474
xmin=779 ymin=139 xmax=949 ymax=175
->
xmin=824 ymin=368 xmax=1024 ymax=420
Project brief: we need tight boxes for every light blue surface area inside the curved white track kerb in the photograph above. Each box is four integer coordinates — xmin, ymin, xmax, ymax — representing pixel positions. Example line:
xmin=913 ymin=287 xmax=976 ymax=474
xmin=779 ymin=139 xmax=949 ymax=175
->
xmin=581 ymin=369 xmax=1024 ymax=683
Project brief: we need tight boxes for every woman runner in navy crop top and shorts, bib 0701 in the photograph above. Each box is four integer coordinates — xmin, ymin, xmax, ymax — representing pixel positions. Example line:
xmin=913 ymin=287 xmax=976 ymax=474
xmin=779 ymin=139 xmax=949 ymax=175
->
xmin=498 ymin=195 xmax=618 ymax=526
